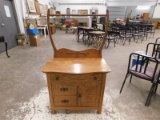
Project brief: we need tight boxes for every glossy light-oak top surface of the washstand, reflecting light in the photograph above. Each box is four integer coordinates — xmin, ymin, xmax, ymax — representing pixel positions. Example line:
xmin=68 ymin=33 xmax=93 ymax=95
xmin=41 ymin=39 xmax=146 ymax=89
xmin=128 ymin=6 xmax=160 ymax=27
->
xmin=42 ymin=58 xmax=111 ymax=74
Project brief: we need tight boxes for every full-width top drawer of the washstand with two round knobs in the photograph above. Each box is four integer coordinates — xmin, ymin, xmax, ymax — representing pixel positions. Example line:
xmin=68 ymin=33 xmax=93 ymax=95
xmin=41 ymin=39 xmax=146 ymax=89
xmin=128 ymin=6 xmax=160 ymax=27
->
xmin=50 ymin=73 xmax=103 ymax=85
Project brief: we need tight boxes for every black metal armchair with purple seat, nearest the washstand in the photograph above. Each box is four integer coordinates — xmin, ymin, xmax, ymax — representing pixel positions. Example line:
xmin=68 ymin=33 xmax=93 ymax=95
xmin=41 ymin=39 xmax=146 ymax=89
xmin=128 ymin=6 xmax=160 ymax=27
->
xmin=120 ymin=53 xmax=158 ymax=105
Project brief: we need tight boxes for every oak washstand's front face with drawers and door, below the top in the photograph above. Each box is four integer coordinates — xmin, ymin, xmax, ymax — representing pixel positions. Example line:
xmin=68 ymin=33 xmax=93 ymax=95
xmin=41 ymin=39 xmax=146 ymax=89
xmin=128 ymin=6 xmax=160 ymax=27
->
xmin=49 ymin=73 xmax=103 ymax=107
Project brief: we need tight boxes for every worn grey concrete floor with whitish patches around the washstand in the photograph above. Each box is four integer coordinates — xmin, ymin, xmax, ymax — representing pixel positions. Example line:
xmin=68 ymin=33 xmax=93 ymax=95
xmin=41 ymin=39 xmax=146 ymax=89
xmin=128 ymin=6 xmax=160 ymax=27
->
xmin=0 ymin=30 xmax=160 ymax=120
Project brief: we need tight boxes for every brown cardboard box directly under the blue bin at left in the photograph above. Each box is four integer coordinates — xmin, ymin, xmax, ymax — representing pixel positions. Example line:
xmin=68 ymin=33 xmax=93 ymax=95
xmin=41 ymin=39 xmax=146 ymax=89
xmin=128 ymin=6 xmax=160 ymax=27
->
xmin=28 ymin=34 xmax=41 ymax=46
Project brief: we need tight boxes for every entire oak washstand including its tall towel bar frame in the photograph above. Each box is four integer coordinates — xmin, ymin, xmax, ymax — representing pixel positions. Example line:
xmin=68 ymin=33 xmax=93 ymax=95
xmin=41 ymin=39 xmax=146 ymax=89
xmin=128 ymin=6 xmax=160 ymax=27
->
xmin=42 ymin=10 xmax=111 ymax=114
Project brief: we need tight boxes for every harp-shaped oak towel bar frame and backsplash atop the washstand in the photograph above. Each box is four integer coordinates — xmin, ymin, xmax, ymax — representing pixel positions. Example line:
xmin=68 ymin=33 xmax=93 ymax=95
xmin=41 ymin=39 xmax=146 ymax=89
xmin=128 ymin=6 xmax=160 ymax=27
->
xmin=47 ymin=9 xmax=109 ymax=58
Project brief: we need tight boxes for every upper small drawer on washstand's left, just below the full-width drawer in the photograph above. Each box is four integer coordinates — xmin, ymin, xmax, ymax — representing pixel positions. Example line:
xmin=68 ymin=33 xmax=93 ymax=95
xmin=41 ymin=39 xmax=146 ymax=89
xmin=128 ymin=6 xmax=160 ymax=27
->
xmin=52 ymin=84 xmax=77 ymax=95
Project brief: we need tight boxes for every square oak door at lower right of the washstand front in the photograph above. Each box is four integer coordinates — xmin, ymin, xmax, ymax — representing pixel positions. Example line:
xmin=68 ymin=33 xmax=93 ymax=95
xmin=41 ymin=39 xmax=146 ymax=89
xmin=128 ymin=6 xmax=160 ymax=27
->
xmin=78 ymin=84 xmax=101 ymax=107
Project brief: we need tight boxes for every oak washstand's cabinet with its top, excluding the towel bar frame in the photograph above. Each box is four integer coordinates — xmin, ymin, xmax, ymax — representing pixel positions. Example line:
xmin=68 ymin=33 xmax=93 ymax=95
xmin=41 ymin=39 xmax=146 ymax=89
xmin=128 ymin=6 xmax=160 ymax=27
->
xmin=42 ymin=58 xmax=111 ymax=114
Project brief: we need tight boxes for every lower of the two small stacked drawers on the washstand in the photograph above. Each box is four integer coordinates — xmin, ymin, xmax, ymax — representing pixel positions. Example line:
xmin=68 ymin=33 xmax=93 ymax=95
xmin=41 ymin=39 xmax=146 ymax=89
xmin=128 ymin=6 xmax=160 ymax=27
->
xmin=54 ymin=96 xmax=77 ymax=107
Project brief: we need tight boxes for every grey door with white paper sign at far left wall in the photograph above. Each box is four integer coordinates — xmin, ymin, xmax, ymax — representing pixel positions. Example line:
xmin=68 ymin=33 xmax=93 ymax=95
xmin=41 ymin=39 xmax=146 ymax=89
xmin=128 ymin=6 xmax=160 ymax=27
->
xmin=0 ymin=0 xmax=18 ymax=52
